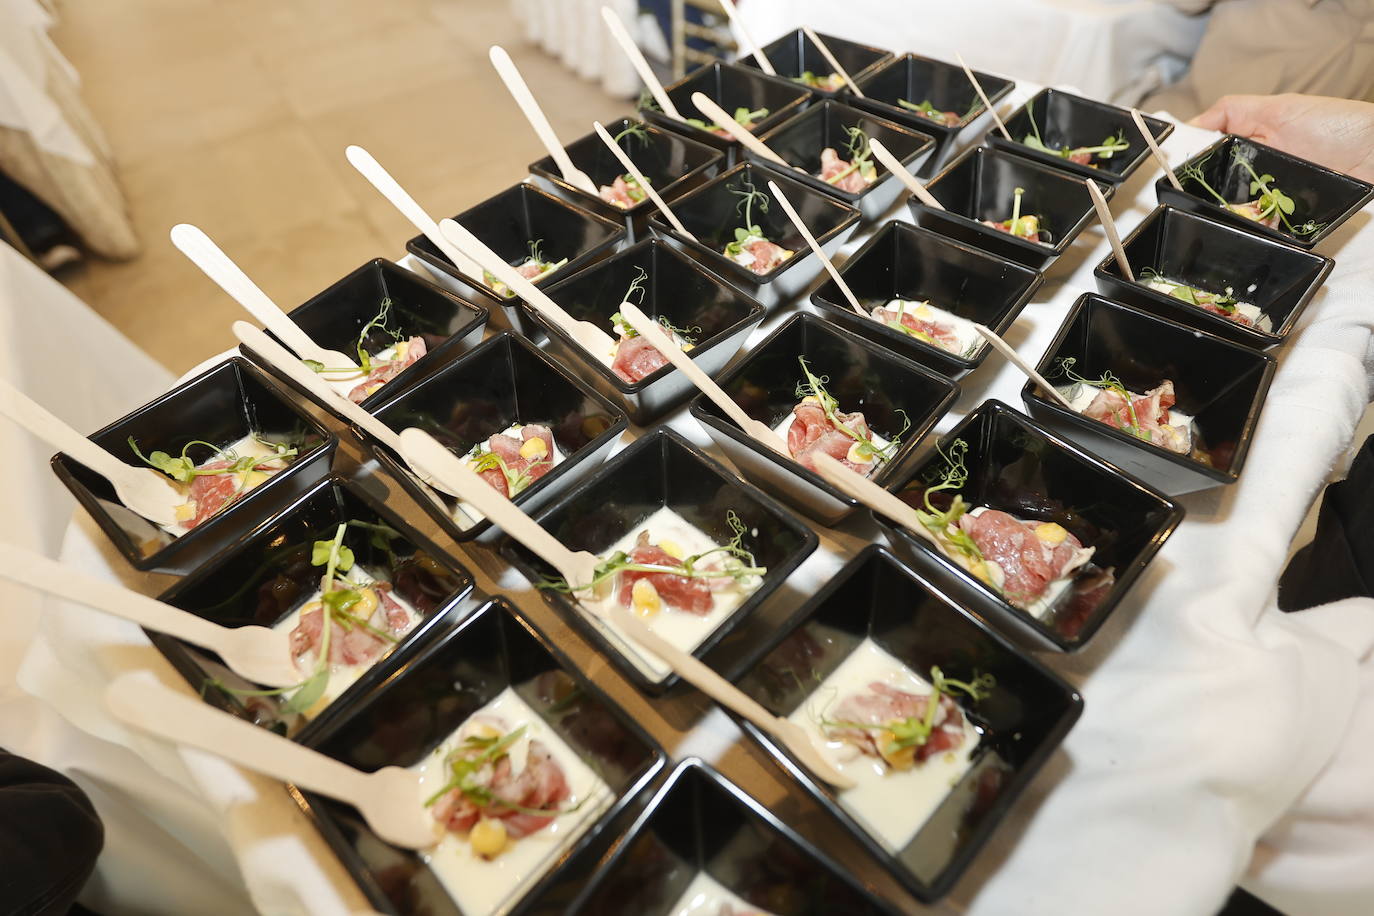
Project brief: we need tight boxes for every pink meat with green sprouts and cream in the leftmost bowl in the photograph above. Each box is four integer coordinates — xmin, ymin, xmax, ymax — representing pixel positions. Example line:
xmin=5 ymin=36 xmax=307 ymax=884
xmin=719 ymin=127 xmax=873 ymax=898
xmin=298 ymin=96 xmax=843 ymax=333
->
xmin=129 ymin=433 xmax=300 ymax=536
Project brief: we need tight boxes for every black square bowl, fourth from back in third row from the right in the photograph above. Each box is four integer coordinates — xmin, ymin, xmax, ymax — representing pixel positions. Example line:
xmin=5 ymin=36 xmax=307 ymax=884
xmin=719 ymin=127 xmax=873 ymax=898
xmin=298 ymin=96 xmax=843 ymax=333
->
xmin=530 ymin=239 xmax=764 ymax=424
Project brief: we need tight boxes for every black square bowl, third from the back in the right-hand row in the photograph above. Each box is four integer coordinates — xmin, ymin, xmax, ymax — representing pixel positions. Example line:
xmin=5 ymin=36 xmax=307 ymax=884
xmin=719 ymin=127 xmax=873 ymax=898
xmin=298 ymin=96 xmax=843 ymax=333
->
xmin=1021 ymin=293 xmax=1276 ymax=494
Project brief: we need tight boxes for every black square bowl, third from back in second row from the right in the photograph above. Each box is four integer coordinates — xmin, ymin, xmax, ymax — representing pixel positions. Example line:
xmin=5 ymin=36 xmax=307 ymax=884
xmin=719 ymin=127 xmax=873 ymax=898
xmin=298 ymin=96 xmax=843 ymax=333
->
xmin=811 ymin=220 xmax=1044 ymax=378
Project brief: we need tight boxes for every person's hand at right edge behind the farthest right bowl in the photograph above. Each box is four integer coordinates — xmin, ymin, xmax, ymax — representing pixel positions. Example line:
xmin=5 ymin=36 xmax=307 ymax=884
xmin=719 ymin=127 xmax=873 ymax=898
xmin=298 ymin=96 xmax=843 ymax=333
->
xmin=1190 ymin=93 xmax=1374 ymax=181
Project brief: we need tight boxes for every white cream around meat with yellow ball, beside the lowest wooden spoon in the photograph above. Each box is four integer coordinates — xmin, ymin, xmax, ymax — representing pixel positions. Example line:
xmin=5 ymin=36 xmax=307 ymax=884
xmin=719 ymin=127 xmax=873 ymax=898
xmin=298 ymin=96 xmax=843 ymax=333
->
xmin=411 ymin=687 xmax=614 ymax=916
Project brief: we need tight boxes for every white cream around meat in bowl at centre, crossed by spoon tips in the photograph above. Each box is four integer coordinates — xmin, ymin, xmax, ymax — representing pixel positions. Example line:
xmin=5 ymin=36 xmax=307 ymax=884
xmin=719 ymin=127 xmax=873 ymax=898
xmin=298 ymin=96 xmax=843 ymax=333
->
xmin=577 ymin=505 xmax=763 ymax=681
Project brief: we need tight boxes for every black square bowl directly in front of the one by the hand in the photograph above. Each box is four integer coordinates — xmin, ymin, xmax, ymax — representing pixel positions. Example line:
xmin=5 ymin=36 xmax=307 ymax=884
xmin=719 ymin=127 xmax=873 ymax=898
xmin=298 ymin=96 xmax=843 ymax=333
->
xmin=1092 ymin=206 xmax=1336 ymax=349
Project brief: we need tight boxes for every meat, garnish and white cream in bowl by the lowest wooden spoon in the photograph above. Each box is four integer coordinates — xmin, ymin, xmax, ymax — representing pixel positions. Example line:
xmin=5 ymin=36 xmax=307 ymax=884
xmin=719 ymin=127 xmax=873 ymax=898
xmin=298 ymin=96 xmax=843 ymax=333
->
xmin=411 ymin=687 xmax=614 ymax=913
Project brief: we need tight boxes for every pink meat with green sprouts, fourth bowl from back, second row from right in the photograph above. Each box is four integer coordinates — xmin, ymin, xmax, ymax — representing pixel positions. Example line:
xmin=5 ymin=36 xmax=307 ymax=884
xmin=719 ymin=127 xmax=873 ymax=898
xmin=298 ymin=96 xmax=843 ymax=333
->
xmin=774 ymin=357 xmax=911 ymax=477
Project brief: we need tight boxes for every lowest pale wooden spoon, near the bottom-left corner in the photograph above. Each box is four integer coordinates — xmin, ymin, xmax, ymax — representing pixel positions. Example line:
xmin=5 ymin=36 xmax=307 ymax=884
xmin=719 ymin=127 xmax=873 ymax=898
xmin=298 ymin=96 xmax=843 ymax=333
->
xmin=104 ymin=672 xmax=440 ymax=849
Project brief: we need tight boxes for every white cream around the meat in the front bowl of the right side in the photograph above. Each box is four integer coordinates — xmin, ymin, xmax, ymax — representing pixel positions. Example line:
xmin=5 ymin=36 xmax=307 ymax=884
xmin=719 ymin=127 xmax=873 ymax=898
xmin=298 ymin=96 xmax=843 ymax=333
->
xmin=787 ymin=639 xmax=981 ymax=853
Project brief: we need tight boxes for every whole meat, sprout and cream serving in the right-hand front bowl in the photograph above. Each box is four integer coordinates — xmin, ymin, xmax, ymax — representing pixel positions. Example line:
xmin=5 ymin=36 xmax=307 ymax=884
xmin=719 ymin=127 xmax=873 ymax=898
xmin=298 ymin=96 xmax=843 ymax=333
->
xmin=789 ymin=639 xmax=996 ymax=853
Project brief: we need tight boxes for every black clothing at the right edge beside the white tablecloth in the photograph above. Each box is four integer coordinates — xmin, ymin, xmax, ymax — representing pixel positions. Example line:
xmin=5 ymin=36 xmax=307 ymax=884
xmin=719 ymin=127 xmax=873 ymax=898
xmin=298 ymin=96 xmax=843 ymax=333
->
xmin=1279 ymin=437 xmax=1374 ymax=611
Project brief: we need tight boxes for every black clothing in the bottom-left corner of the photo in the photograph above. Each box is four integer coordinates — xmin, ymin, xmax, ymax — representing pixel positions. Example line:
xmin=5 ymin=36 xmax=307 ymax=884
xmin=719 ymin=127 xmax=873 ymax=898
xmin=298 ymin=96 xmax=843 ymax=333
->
xmin=0 ymin=750 xmax=104 ymax=916
